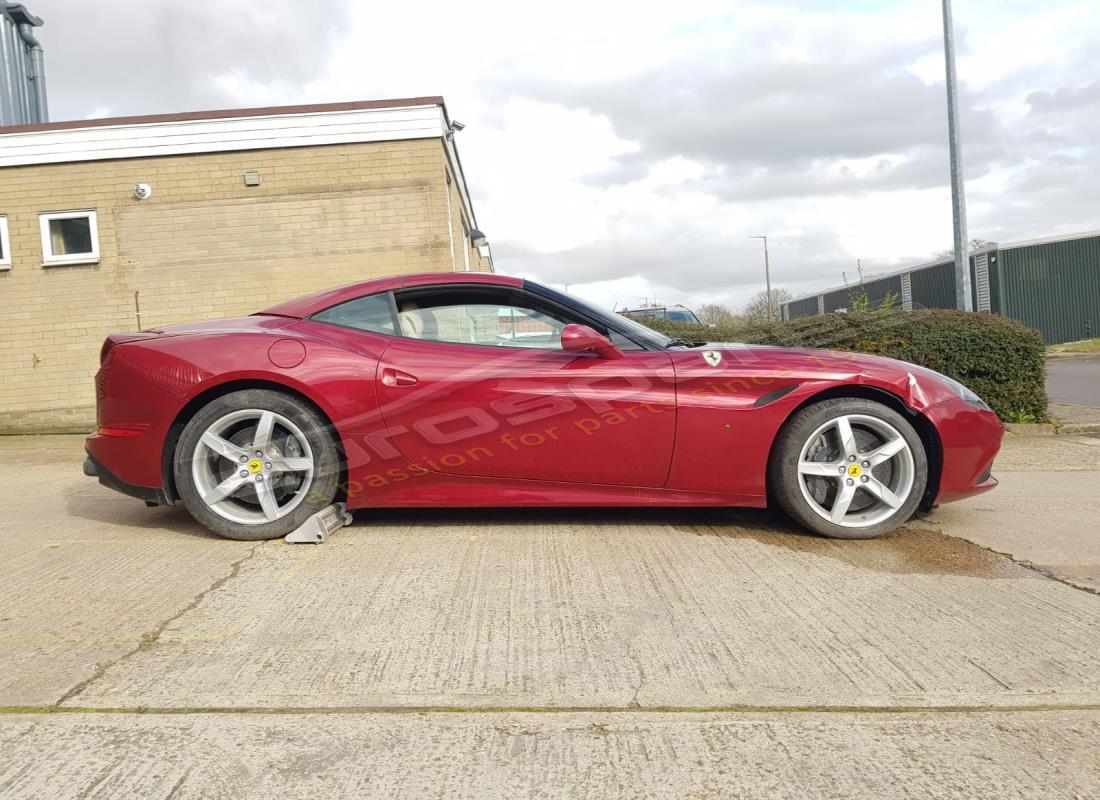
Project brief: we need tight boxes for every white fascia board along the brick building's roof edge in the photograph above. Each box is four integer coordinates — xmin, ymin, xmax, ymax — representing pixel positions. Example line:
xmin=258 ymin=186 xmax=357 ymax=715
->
xmin=0 ymin=106 xmax=446 ymax=167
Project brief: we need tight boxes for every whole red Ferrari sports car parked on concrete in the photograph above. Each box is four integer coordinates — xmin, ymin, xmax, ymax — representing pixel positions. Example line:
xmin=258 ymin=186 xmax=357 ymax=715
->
xmin=85 ymin=273 xmax=1002 ymax=539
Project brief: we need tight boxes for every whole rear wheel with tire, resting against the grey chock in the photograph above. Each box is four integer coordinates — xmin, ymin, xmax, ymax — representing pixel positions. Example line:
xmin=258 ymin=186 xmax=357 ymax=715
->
xmin=174 ymin=390 xmax=340 ymax=540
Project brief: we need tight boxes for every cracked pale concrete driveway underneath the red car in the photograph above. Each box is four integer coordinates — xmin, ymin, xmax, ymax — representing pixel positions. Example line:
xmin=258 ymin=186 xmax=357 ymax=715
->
xmin=0 ymin=437 xmax=1100 ymax=798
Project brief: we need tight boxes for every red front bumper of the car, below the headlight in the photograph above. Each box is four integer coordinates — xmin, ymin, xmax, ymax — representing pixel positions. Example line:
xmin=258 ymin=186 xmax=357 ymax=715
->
xmin=925 ymin=398 xmax=1004 ymax=505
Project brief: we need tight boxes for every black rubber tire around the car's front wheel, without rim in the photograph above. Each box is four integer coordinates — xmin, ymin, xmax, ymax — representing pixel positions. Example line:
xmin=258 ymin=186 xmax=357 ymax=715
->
xmin=768 ymin=397 xmax=928 ymax=539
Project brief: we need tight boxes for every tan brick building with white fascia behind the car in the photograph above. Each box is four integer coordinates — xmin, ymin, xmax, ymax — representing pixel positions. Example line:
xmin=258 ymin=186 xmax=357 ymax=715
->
xmin=0 ymin=97 xmax=492 ymax=432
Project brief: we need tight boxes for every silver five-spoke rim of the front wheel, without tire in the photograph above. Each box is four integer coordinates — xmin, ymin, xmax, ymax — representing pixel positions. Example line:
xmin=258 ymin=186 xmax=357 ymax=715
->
xmin=799 ymin=414 xmax=916 ymax=528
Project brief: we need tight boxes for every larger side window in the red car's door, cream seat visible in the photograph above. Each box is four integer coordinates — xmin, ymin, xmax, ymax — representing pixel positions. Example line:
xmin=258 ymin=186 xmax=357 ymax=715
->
xmin=397 ymin=298 xmax=567 ymax=350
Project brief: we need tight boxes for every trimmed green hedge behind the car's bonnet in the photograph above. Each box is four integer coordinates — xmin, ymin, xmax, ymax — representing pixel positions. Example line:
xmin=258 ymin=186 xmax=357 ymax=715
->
xmin=639 ymin=310 xmax=1046 ymax=421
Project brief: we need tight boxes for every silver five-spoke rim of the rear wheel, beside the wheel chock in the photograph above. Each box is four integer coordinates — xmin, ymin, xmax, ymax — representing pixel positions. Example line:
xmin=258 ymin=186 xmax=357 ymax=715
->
xmin=191 ymin=408 xmax=314 ymax=525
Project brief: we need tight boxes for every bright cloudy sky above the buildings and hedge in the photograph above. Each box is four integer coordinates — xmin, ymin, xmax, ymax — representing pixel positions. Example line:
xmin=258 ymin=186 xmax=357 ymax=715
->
xmin=24 ymin=0 xmax=1100 ymax=307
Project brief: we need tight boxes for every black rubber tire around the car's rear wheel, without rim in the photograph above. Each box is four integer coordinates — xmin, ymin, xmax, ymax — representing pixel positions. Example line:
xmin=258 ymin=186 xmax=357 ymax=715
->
xmin=173 ymin=390 xmax=340 ymax=541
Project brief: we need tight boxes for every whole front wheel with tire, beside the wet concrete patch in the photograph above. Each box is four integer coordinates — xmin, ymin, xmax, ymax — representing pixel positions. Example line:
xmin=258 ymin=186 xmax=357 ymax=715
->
xmin=769 ymin=397 xmax=928 ymax=539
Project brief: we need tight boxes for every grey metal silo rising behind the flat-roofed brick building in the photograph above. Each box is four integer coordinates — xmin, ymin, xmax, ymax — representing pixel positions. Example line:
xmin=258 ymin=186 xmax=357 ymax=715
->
xmin=0 ymin=0 xmax=50 ymax=125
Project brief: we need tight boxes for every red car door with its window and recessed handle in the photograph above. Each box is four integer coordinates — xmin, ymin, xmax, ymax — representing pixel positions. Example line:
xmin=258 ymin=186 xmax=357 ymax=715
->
xmin=378 ymin=286 xmax=677 ymax=487
